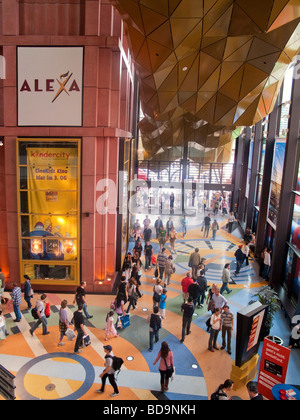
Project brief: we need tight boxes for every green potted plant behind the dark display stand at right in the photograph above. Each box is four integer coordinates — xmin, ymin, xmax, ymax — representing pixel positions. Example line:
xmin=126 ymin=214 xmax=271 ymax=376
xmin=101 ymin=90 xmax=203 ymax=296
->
xmin=249 ymin=286 xmax=280 ymax=339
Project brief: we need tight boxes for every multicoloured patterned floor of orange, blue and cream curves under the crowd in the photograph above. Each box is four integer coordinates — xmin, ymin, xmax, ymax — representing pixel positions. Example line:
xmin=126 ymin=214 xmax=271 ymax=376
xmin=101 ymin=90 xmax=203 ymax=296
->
xmin=0 ymin=216 xmax=300 ymax=401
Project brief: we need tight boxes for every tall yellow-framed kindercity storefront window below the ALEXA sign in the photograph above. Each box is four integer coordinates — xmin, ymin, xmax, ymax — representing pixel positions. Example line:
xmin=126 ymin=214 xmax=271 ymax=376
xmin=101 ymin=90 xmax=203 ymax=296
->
xmin=18 ymin=139 xmax=80 ymax=284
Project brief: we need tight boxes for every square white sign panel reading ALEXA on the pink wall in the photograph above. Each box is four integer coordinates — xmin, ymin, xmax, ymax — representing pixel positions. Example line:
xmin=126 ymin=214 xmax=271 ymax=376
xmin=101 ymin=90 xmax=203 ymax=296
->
xmin=17 ymin=47 xmax=83 ymax=126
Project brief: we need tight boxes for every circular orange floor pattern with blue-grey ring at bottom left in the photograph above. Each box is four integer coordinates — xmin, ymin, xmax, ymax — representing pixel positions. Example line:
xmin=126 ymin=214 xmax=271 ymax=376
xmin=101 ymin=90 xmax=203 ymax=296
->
xmin=15 ymin=353 xmax=95 ymax=400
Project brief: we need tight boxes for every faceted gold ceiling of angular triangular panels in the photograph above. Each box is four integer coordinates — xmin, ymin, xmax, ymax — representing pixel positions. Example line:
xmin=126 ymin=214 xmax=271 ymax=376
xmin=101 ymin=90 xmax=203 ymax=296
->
xmin=111 ymin=0 xmax=300 ymax=157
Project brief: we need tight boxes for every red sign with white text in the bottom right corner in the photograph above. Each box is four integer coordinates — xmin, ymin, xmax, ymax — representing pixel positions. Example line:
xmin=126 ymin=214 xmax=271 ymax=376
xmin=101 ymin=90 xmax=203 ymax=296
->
xmin=257 ymin=338 xmax=291 ymax=400
